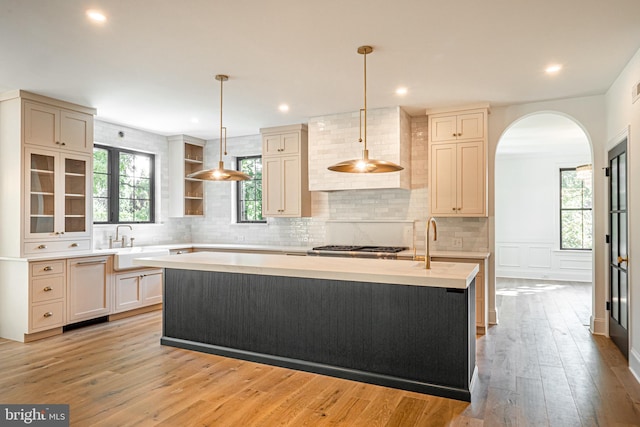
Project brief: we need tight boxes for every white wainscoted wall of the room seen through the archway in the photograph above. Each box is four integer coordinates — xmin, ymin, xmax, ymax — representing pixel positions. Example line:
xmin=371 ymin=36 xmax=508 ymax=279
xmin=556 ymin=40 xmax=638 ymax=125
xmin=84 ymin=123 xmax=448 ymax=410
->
xmin=495 ymin=152 xmax=592 ymax=282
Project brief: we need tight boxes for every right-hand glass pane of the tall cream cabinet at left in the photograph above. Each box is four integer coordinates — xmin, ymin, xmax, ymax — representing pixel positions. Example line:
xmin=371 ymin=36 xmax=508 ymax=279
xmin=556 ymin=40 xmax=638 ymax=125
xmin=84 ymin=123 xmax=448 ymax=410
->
xmin=63 ymin=157 xmax=88 ymax=233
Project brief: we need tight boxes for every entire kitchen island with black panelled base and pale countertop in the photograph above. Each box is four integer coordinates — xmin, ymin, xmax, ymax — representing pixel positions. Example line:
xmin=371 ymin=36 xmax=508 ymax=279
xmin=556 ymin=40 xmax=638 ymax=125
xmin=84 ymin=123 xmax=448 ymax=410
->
xmin=134 ymin=253 xmax=478 ymax=401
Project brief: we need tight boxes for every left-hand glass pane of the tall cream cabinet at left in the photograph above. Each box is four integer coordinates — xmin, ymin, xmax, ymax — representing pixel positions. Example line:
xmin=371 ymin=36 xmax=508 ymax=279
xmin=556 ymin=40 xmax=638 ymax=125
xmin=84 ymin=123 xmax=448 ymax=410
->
xmin=28 ymin=153 xmax=56 ymax=234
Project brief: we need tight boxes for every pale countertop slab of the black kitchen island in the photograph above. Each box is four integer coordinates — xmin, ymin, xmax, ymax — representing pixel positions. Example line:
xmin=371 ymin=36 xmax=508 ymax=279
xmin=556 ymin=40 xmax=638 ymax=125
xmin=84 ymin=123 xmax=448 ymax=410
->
xmin=133 ymin=252 xmax=478 ymax=289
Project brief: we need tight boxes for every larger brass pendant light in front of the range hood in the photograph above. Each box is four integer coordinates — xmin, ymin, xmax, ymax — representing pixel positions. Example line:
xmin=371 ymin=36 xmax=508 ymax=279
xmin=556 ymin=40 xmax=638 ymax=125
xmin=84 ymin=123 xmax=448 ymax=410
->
xmin=328 ymin=46 xmax=404 ymax=173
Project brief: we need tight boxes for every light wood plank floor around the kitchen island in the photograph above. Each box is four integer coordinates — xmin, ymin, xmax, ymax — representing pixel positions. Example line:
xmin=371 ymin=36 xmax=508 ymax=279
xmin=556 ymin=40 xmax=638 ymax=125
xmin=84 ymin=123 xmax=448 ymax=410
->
xmin=0 ymin=280 xmax=640 ymax=427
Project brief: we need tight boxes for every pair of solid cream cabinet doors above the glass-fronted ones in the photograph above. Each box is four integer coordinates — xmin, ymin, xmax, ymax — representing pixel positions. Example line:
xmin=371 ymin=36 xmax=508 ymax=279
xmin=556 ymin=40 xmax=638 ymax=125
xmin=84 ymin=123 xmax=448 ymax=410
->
xmin=23 ymin=101 xmax=93 ymax=153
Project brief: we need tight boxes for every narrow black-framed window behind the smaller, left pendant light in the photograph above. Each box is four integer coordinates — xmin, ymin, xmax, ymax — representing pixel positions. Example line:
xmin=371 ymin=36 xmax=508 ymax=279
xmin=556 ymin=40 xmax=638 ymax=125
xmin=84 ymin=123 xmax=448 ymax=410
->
xmin=237 ymin=156 xmax=267 ymax=222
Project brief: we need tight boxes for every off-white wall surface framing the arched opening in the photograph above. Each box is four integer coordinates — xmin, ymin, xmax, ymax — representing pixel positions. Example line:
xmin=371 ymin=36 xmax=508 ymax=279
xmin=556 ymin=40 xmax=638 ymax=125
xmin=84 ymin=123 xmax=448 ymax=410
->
xmin=488 ymin=96 xmax=607 ymax=333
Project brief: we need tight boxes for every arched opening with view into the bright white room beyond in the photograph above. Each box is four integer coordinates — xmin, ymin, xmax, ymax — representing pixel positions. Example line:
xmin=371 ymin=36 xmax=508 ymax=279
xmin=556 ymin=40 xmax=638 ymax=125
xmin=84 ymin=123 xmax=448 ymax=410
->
xmin=494 ymin=111 xmax=594 ymax=326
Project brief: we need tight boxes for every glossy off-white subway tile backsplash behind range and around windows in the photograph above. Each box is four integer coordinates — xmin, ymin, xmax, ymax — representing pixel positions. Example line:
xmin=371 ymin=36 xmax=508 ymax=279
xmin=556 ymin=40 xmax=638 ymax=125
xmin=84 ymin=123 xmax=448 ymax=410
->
xmin=94 ymin=114 xmax=489 ymax=251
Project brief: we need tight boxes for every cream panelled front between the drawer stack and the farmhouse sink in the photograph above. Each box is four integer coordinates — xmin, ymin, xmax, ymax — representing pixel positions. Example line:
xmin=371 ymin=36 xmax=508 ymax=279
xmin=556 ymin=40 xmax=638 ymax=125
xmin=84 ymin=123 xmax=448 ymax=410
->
xmin=67 ymin=256 xmax=111 ymax=323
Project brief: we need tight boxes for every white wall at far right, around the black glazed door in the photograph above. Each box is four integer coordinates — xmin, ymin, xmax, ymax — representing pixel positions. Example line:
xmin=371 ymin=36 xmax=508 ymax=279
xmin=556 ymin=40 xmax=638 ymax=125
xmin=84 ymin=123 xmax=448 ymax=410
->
xmin=601 ymin=46 xmax=640 ymax=381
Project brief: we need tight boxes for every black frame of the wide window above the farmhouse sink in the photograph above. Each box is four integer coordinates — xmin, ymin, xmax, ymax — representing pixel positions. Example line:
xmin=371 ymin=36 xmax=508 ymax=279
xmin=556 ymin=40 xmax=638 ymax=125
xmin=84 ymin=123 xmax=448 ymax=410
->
xmin=91 ymin=144 xmax=156 ymax=225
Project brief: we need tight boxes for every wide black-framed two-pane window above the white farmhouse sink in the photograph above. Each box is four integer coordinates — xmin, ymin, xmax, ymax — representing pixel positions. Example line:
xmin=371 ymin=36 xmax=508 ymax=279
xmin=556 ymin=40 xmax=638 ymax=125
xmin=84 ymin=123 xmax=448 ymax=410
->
xmin=93 ymin=145 xmax=155 ymax=224
